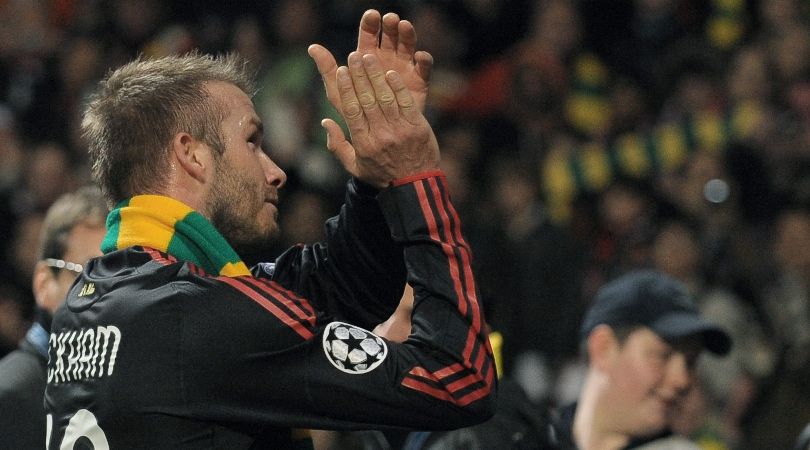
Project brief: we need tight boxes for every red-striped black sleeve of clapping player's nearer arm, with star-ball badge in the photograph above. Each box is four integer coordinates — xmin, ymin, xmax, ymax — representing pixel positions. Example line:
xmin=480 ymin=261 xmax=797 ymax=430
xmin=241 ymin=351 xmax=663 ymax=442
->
xmin=183 ymin=173 xmax=497 ymax=429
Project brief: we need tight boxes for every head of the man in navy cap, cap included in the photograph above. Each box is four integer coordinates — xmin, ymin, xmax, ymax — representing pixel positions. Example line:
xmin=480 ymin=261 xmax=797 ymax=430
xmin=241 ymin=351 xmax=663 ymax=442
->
xmin=580 ymin=271 xmax=731 ymax=437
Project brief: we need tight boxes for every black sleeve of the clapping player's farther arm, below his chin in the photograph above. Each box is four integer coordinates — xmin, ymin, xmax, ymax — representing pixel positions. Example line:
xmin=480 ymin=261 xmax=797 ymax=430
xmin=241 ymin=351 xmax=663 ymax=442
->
xmin=254 ymin=179 xmax=405 ymax=328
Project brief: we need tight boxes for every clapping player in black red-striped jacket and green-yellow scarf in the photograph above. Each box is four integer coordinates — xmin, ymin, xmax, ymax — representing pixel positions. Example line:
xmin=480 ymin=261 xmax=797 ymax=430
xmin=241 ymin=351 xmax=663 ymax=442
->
xmin=45 ymin=11 xmax=496 ymax=449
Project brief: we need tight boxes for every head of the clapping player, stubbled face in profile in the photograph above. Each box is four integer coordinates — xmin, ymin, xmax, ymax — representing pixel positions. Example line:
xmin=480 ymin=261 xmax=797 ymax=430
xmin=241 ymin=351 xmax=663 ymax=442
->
xmin=82 ymin=54 xmax=286 ymax=251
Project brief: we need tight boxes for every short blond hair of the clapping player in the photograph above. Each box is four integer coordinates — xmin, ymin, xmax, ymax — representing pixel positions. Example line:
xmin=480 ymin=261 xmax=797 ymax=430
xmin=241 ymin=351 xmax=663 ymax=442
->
xmin=82 ymin=52 xmax=255 ymax=205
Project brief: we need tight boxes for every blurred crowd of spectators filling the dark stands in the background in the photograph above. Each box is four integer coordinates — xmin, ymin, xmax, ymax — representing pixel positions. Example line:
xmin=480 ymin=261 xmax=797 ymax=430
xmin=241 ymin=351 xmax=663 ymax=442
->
xmin=0 ymin=0 xmax=810 ymax=449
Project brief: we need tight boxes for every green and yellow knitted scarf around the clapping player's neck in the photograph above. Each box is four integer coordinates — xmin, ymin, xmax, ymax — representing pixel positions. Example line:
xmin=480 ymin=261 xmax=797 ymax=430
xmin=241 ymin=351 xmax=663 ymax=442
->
xmin=101 ymin=195 xmax=250 ymax=277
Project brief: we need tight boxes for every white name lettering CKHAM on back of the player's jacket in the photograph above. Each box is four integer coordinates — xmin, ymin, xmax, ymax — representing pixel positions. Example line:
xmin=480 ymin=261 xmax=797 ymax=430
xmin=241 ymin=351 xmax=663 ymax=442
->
xmin=48 ymin=325 xmax=121 ymax=384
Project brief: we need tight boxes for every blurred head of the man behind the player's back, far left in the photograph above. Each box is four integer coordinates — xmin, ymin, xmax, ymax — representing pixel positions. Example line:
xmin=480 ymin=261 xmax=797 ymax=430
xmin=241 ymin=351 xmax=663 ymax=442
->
xmin=32 ymin=186 xmax=107 ymax=314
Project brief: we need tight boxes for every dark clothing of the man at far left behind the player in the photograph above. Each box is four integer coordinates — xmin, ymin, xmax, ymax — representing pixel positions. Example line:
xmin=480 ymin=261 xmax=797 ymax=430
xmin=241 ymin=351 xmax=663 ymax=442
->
xmin=0 ymin=314 xmax=48 ymax=450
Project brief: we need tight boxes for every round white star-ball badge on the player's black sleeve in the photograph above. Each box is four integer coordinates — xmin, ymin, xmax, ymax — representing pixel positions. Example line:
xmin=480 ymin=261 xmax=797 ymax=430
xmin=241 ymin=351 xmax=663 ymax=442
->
xmin=323 ymin=322 xmax=388 ymax=375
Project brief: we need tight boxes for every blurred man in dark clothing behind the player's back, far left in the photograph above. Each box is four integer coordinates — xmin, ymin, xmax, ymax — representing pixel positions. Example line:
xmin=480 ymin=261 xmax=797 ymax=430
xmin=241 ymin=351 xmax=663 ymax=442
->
xmin=0 ymin=187 xmax=107 ymax=449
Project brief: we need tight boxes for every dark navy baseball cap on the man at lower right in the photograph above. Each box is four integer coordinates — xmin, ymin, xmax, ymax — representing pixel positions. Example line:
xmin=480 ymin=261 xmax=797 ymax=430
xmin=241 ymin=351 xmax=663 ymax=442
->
xmin=580 ymin=270 xmax=731 ymax=355
